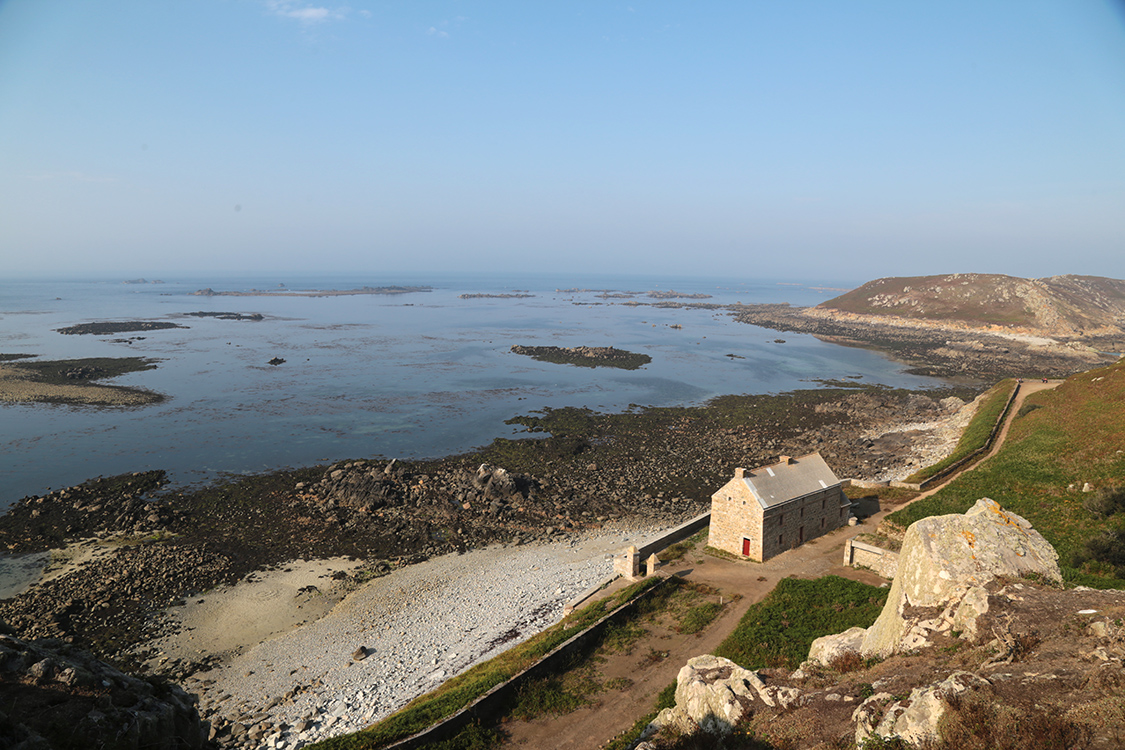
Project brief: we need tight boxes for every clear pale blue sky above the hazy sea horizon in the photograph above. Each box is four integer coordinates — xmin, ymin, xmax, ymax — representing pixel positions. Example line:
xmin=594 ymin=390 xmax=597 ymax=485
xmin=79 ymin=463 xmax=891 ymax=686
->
xmin=0 ymin=0 xmax=1125 ymax=281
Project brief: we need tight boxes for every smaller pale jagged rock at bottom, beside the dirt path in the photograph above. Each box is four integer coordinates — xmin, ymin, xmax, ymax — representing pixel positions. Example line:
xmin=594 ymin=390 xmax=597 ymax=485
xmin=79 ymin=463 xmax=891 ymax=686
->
xmin=646 ymin=654 xmax=801 ymax=735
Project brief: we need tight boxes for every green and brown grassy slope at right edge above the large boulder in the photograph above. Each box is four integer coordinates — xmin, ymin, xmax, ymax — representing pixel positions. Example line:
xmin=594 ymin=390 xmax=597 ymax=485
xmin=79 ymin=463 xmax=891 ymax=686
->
xmin=888 ymin=362 xmax=1125 ymax=586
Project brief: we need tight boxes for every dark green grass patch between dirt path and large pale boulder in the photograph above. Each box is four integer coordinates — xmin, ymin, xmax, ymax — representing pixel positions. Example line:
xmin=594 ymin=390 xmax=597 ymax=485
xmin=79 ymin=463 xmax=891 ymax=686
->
xmin=714 ymin=576 xmax=889 ymax=669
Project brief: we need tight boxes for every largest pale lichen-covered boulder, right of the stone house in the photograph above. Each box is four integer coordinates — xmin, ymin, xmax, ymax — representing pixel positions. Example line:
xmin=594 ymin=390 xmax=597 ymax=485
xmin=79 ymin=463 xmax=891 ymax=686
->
xmin=861 ymin=498 xmax=1062 ymax=656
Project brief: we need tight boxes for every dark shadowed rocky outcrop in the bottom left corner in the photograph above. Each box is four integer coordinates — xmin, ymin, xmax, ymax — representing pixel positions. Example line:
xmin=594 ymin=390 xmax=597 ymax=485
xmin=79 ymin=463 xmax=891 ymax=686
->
xmin=0 ymin=635 xmax=207 ymax=750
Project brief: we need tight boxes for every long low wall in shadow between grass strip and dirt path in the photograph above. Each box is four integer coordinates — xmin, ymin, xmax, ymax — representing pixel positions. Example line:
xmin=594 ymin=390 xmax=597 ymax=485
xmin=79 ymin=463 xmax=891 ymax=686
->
xmin=385 ymin=579 xmax=668 ymax=750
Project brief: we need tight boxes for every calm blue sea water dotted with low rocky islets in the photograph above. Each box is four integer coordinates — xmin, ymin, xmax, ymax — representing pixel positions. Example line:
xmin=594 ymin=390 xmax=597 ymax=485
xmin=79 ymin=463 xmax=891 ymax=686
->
xmin=0 ymin=275 xmax=939 ymax=507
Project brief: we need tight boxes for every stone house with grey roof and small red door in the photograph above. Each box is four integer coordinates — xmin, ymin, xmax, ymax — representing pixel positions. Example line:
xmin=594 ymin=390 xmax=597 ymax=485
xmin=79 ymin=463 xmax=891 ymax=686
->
xmin=708 ymin=453 xmax=852 ymax=562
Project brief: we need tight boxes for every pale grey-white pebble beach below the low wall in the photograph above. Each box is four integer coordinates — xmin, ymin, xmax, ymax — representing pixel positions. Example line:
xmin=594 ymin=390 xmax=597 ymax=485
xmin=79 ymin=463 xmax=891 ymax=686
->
xmin=166 ymin=526 xmax=664 ymax=749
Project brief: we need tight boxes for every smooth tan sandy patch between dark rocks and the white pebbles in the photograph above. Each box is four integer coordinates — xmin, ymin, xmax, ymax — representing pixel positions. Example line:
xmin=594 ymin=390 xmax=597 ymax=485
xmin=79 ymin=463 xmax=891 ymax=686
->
xmin=149 ymin=558 xmax=362 ymax=659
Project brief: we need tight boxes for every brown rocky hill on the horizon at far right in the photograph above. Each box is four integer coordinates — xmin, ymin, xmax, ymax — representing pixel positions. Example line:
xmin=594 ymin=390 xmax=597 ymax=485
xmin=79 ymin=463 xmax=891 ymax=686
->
xmin=818 ymin=273 xmax=1125 ymax=337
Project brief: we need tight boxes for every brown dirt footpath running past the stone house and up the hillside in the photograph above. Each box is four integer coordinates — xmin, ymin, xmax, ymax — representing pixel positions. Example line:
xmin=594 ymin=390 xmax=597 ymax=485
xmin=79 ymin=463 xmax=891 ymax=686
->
xmin=503 ymin=380 xmax=1062 ymax=750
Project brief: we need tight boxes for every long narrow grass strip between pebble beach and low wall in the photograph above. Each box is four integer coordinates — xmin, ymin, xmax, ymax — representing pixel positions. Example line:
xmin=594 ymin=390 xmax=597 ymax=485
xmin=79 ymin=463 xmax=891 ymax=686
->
xmin=312 ymin=578 xmax=666 ymax=750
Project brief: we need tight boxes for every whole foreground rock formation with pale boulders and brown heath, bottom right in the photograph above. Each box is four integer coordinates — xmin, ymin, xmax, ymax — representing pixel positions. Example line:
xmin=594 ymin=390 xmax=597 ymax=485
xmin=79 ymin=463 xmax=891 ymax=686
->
xmin=637 ymin=498 xmax=1125 ymax=750
